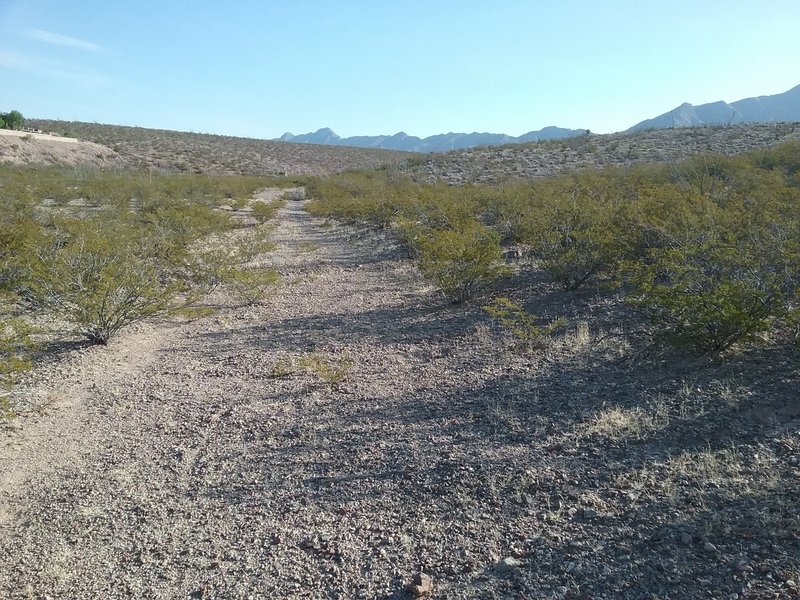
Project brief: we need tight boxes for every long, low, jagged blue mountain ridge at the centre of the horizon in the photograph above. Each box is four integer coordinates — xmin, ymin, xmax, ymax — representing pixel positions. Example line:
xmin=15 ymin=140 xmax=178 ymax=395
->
xmin=275 ymin=126 xmax=586 ymax=152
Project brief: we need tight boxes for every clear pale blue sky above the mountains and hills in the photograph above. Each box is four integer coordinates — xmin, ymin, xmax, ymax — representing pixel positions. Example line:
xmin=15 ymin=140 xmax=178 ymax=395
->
xmin=0 ymin=0 xmax=800 ymax=138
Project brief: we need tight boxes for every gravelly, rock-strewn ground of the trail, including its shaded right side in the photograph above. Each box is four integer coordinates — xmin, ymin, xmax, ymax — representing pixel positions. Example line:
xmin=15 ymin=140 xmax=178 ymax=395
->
xmin=0 ymin=195 xmax=800 ymax=600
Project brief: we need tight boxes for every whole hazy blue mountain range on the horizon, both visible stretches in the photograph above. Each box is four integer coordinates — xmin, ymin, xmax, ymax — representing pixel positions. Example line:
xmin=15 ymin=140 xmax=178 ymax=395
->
xmin=276 ymin=85 xmax=800 ymax=152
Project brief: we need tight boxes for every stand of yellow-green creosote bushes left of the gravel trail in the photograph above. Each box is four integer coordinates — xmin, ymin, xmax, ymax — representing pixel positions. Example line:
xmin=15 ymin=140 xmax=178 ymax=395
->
xmin=0 ymin=167 xmax=284 ymax=344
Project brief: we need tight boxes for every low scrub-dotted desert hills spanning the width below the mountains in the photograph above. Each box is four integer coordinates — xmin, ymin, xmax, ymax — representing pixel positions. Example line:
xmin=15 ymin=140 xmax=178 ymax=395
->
xmin=14 ymin=120 xmax=800 ymax=184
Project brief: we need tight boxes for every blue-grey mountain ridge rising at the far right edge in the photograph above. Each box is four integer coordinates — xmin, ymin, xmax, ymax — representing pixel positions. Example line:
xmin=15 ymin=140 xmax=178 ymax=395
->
xmin=627 ymin=85 xmax=800 ymax=132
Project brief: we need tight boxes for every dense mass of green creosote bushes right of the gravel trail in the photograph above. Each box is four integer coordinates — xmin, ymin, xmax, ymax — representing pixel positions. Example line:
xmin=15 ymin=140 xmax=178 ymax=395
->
xmin=306 ymin=142 xmax=800 ymax=352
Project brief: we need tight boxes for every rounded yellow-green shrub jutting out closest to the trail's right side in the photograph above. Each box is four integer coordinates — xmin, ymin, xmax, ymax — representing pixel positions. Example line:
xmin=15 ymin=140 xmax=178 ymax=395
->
xmin=418 ymin=222 xmax=509 ymax=302
